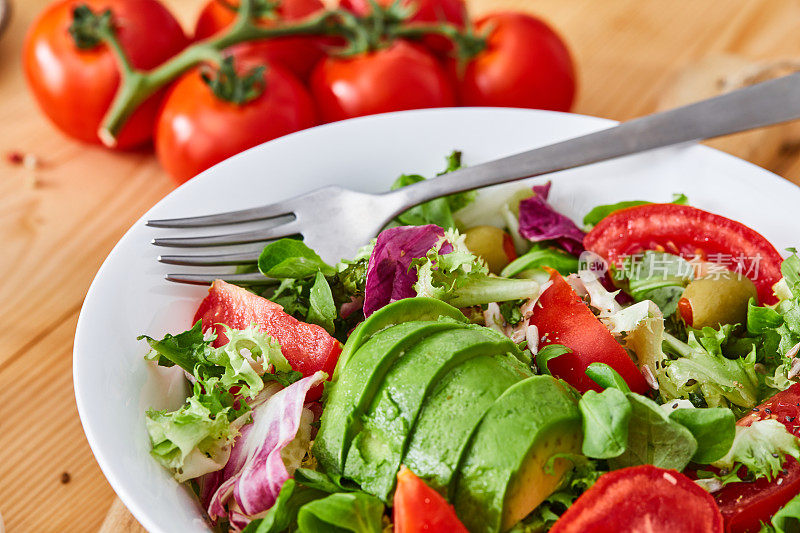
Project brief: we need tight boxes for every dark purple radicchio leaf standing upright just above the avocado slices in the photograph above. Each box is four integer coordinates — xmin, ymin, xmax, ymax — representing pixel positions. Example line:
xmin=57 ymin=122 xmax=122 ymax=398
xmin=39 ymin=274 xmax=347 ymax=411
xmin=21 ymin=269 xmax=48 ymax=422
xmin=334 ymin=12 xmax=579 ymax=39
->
xmin=364 ymin=224 xmax=453 ymax=317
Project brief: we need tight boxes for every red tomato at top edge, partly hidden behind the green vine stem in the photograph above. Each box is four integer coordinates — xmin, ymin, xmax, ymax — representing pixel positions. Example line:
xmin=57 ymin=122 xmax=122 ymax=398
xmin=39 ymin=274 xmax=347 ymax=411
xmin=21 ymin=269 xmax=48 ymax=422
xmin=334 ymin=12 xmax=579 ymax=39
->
xmin=339 ymin=0 xmax=467 ymax=53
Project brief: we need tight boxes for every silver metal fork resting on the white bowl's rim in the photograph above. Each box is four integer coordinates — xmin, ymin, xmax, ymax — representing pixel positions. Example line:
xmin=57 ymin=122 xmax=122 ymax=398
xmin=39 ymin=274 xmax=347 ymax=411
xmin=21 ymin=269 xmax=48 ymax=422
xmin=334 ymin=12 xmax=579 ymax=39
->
xmin=152 ymin=73 xmax=800 ymax=284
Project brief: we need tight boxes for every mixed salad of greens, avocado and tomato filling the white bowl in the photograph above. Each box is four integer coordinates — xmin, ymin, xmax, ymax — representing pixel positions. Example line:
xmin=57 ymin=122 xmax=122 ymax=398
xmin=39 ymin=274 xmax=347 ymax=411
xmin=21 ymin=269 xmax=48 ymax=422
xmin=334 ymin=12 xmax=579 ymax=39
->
xmin=140 ymin=152 xmax=800 ymax=533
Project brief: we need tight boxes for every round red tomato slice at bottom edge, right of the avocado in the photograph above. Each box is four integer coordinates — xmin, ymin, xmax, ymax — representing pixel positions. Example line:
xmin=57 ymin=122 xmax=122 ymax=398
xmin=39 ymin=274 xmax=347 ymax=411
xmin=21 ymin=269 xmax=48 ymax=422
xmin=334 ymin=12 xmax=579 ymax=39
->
xmin=550 ymin=465 xmax=723 ymax=533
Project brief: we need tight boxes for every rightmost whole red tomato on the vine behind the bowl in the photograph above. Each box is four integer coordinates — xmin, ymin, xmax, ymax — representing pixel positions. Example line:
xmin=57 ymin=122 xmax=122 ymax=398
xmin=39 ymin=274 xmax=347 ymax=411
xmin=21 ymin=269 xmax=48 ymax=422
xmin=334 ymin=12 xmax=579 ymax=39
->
xmin=451 ymin=13 xmax=576 ymax=111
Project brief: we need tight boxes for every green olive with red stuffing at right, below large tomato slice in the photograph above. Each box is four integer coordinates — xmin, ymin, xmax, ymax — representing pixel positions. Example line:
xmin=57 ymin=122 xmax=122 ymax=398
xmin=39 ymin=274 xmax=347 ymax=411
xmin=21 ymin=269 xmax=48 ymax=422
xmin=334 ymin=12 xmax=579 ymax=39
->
xmin=678 ymin=272 xmax=757 ymax=328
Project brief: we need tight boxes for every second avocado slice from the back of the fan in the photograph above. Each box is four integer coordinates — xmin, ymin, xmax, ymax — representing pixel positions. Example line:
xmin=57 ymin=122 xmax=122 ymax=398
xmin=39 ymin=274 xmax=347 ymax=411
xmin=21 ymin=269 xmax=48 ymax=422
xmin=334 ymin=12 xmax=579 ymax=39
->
xmin=312 ymin=320 xmax=467 ymax=477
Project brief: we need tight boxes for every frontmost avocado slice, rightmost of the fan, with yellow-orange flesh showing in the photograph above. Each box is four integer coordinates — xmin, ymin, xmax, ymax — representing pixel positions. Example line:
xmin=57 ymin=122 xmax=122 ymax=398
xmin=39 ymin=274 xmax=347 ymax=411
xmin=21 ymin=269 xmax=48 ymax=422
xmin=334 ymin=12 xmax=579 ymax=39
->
xmin=453 ymin=375 xmax=582 ymax=533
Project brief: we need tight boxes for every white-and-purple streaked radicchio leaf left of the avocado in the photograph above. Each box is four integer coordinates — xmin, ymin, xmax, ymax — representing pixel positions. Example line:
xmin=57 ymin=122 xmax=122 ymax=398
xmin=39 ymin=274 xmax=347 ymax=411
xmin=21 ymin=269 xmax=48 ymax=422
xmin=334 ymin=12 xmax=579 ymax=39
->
xmin=204 ymin=371 xmax=327 ymax=528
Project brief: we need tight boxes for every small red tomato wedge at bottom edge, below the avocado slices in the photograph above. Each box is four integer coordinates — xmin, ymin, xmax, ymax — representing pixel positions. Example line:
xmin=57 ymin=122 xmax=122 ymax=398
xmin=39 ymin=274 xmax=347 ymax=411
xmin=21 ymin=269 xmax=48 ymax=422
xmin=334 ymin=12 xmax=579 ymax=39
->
xmin=394 ymin=467 xmax=467 ymax=533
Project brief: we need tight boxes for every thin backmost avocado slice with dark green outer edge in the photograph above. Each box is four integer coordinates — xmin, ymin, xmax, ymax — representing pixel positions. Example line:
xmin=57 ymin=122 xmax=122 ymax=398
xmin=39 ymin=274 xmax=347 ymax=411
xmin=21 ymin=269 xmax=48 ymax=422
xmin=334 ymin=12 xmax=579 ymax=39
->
xmin=332 ymin=297 xmax=468 ymax=381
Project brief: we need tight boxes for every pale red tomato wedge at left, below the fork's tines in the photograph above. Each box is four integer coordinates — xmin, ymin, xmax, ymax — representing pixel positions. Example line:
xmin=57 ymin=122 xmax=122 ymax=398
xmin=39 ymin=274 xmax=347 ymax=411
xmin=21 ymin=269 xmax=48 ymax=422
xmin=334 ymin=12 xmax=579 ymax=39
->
xmin=194 ymin=279 xmax=342 ymax=400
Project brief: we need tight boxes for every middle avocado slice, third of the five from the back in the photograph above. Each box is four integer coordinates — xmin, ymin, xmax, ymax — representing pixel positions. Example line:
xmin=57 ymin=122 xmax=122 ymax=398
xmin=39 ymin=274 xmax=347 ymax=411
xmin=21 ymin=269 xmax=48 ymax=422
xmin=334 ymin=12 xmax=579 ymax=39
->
xmin=344 ymin=326 xmax=516 ymax=501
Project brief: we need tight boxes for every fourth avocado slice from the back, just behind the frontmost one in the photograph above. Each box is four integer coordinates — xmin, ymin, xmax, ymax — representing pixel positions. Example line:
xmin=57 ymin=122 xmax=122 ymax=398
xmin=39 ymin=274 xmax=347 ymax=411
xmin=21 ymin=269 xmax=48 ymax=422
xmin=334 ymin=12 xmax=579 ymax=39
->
xmin=403 ymin=354 xmax=533 ymax=497
